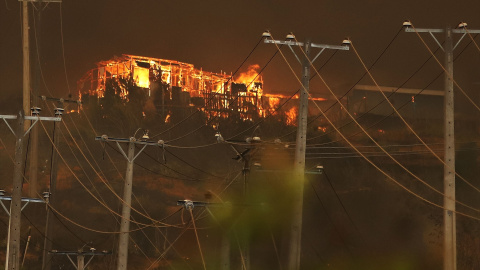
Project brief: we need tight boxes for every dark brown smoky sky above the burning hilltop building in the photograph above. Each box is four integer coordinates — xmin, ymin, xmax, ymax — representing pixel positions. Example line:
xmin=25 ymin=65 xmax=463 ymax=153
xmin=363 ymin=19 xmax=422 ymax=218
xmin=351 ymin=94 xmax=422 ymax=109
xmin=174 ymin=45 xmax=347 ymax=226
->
xmin=0 ymin=0 xmax=480 ymax=103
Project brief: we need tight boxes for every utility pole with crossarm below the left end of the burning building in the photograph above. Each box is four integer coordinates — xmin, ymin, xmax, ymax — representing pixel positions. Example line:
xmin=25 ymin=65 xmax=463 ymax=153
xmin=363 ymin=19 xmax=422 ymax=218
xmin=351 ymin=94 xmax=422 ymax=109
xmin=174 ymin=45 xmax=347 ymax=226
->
xmin=95 ymin=133 xmax=164 ymax=270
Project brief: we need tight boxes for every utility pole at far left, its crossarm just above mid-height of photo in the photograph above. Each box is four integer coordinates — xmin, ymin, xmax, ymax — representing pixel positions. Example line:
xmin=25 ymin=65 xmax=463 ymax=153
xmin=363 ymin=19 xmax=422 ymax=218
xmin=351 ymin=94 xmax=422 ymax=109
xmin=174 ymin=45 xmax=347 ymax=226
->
xmin=0 ymin=108 xmax=61 ymax=270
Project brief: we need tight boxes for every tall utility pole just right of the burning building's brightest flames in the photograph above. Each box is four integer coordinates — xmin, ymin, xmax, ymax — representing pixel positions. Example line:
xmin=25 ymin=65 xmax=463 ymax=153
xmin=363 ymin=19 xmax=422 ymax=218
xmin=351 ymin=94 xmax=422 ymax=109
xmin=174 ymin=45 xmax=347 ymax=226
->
xmin=263 ymin=31 xmax=349 ymax=270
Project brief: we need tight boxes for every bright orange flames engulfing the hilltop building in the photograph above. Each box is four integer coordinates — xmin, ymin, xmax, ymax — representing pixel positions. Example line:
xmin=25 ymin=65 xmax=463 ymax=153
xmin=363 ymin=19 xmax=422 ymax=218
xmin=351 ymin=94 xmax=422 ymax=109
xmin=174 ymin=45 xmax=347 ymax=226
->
xmin=77 ymin=55 xmax=325 ymax=125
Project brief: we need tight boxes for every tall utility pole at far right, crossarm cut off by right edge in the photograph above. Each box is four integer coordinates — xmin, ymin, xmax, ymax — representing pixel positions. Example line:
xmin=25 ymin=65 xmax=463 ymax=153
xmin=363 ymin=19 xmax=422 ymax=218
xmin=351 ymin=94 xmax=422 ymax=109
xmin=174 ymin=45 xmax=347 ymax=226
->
xmin=403 ymin=21 xmax=480 ymax=270
